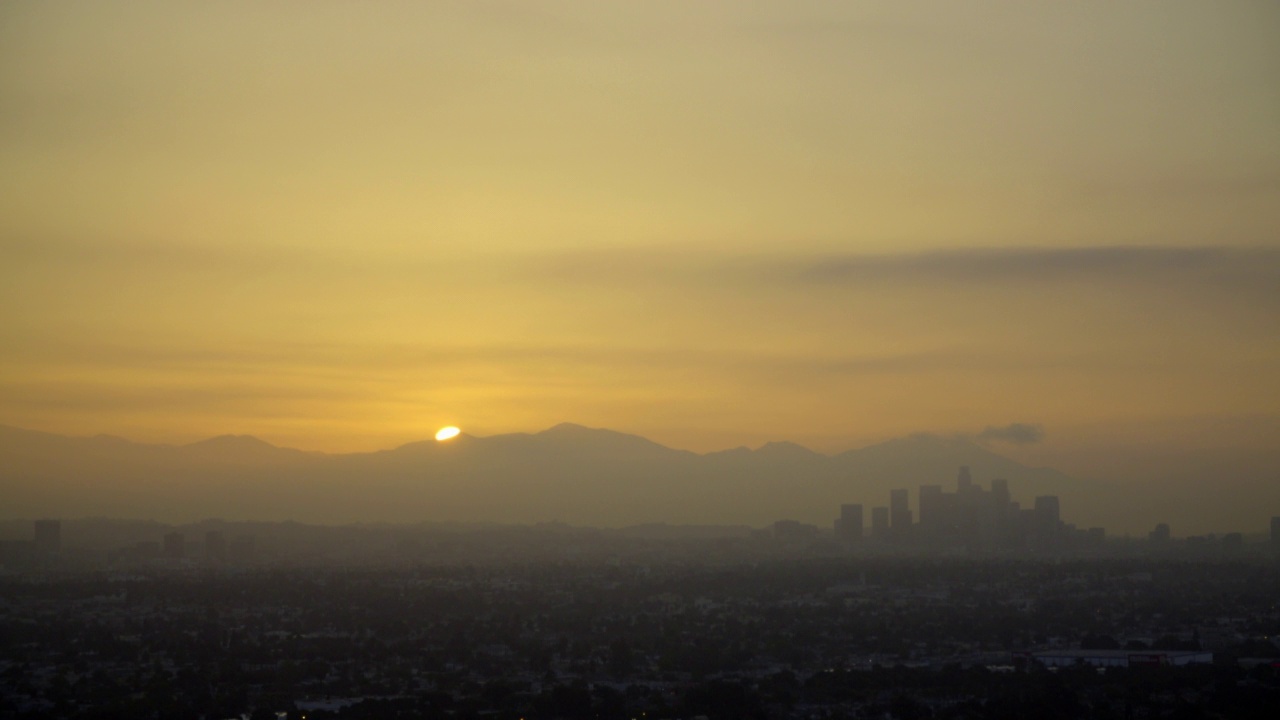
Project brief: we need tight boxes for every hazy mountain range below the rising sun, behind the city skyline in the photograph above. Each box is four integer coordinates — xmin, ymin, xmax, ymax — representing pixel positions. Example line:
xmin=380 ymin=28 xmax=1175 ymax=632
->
xmin=0 ymin=423 xmax=1280 ymax=530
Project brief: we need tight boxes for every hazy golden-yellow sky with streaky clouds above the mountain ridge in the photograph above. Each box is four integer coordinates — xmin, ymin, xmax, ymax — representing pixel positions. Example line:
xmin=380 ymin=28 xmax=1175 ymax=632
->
xmin=0 ymin=0 xmax=1280 ymax=481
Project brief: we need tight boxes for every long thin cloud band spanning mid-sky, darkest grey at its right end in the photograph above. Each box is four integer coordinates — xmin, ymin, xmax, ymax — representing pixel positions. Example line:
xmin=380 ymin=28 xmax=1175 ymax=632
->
xmin=17 ymin=238 xmax=1280 ymax=300
